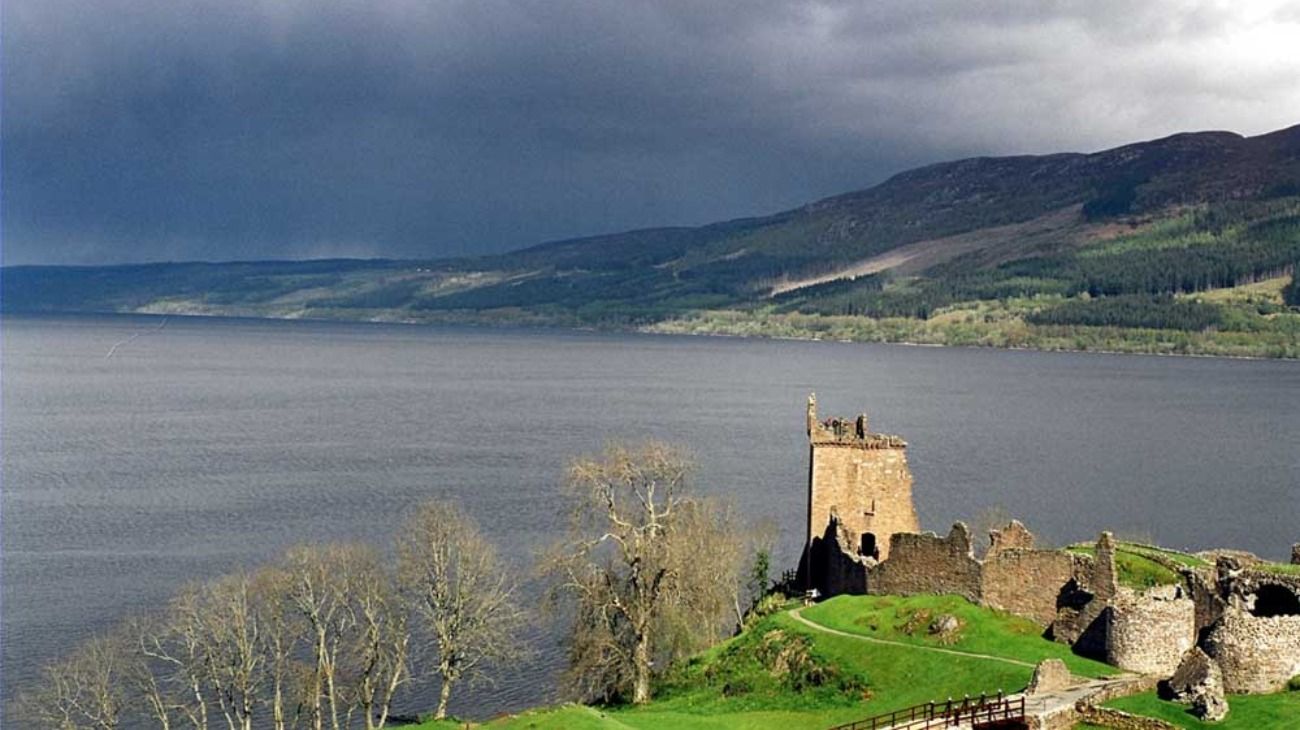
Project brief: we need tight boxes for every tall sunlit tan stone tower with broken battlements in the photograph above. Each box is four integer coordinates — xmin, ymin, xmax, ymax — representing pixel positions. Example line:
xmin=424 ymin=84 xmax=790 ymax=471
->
xmin=805 ymin=394 xmax=920 ymax=558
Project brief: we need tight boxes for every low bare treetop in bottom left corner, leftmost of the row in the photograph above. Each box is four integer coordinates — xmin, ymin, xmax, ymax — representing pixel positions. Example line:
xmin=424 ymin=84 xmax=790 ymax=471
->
xmin=14 ymin=636 xmax=126 ymax=730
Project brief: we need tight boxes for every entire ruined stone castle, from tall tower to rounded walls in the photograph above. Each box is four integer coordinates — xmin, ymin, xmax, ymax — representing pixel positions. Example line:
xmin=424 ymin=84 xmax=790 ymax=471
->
xmin=796 ymin=396 xmax=1300 ymax=717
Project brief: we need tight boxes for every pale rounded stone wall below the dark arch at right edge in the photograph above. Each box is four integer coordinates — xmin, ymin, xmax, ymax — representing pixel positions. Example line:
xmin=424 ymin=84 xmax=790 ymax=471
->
xmin=1204 ymin=607 xmax=1300 ymax=692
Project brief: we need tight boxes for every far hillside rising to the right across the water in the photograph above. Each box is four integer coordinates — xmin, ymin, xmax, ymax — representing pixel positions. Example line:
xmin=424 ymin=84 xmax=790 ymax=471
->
xmin=0 ymin=126 xmax=1300 ymax=357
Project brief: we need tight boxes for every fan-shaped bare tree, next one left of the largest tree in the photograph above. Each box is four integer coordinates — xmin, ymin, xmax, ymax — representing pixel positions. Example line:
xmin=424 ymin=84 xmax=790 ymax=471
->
xmin=398 ymin=501 xmax=525 ymax=720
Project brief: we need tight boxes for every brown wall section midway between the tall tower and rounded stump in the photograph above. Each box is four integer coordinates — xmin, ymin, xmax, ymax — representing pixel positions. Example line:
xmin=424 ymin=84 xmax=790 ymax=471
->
xmin=979 ymin=548 xmax=1084 ymax=627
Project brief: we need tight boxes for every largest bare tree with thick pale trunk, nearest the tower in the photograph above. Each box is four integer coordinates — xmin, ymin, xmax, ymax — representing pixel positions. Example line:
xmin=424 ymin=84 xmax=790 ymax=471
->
xmin=543 ymin=442 xmax=740 ymax=704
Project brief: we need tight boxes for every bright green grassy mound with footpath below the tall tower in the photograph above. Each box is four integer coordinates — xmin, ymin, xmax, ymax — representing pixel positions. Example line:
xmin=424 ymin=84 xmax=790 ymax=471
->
xmin=420 ymin=596 xmax=1113 ymax=730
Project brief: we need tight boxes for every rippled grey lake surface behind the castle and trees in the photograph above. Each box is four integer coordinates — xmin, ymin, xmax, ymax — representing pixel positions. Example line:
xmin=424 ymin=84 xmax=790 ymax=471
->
xmin=0 ymin=309 xmax=1300 ymax=716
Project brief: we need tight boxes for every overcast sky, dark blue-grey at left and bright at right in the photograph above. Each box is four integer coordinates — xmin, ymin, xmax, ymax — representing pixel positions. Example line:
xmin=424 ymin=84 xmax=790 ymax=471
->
xmin=0 ymin=0 xmax=1300 ymax=264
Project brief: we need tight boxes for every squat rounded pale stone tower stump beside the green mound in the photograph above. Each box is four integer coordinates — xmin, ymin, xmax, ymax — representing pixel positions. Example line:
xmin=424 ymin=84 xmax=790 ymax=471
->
xmin=1106 ymin=586 xmax=1196 ymax=677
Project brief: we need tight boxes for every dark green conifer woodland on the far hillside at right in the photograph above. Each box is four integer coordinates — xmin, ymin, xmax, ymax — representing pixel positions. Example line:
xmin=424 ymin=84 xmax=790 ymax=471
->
xmin=775 ymin=200 xmax=1300 ymax=330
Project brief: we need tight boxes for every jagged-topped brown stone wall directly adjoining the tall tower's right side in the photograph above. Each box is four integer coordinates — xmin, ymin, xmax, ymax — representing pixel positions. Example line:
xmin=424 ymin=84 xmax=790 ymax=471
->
xmin=867 ymin=522 xmax=982 ymax=603
